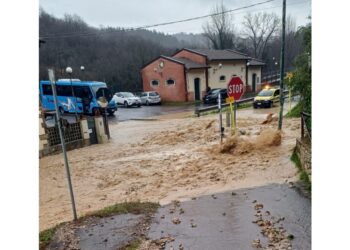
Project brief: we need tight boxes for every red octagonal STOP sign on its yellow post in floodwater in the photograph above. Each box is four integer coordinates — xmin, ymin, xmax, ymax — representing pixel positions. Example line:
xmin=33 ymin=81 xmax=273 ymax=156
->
xmin=227 ymin=76 xmax=244 ymax=135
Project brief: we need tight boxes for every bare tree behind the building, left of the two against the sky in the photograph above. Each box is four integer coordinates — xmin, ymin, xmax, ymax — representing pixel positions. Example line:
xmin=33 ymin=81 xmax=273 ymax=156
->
xmin=203 ymin=3 xmax=235 ymax=49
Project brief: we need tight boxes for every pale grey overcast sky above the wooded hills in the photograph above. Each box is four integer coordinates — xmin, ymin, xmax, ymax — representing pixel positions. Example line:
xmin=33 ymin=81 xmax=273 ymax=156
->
xmin=39 ymin=0 xmax=311 ymax=34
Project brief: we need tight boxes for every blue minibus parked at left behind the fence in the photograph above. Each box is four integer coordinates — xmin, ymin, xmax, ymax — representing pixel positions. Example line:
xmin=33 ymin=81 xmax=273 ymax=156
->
xmin=39 ymin=79 xmax=118 ymax=115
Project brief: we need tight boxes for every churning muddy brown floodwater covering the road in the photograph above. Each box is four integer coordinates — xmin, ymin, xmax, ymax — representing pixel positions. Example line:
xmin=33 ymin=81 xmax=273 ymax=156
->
xmin=40 ymin=107 xmax=300 ymax=230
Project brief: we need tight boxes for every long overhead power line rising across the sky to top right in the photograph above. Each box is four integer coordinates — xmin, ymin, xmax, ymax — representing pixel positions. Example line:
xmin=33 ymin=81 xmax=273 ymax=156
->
xmin=40 ymin=0 xmax=275 ymax=39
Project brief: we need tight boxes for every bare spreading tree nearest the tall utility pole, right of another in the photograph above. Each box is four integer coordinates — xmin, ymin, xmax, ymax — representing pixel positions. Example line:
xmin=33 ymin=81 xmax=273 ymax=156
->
xmin=243 ymin=13 xmax=280 ymax=59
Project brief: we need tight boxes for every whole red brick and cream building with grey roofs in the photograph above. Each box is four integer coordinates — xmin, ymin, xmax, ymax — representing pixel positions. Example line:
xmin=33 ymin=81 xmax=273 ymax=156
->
xmin=141 ymin=48 xmax=264 ymax=102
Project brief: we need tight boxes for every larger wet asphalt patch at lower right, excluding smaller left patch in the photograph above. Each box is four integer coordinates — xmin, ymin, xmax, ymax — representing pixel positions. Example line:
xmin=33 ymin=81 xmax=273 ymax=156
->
xmin=149 ymin=184 xmax=311 ymax=250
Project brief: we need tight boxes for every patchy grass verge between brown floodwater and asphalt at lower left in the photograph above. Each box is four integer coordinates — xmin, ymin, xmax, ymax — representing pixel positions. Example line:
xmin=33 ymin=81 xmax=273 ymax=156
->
xmin=39 ymin=201 xmax=160 ymax=250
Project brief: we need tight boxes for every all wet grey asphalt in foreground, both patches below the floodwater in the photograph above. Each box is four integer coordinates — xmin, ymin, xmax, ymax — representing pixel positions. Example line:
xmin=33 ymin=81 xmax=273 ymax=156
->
xmin=66 ymin=183 xmax=311 ymax=250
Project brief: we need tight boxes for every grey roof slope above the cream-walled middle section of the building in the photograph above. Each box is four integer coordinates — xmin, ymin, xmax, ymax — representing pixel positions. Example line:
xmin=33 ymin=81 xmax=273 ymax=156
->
xmin=185 ymin=49 xmax=250 ymax=60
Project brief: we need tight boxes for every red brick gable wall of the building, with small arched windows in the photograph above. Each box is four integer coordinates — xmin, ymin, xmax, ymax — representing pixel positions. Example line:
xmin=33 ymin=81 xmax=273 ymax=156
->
xmin=141 ymin=58 xmax=187 ymax=102
